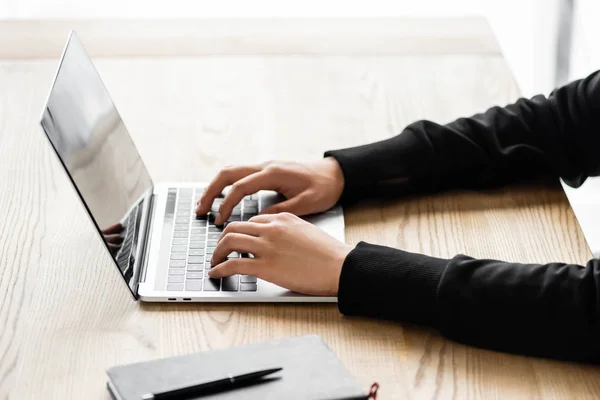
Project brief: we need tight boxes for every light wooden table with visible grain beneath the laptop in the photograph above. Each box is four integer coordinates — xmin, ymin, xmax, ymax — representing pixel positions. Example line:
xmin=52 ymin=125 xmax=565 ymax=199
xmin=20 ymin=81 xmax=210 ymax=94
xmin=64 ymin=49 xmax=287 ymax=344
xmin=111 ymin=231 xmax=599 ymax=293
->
xmin=0 ymin=18 xmax=600 ymax=399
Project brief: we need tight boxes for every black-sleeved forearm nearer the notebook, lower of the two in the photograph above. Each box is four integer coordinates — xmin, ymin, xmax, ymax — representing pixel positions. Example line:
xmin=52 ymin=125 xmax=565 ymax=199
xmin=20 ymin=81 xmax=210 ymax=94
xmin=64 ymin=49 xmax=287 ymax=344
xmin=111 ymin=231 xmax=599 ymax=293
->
xmin=338 ymin=243 xmax=600 ymax=362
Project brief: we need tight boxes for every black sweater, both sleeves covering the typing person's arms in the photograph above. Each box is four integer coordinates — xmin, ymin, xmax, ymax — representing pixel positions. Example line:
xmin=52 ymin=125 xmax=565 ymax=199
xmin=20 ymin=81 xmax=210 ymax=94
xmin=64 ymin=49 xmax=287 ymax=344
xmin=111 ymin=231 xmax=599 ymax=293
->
xmin=325 ymin=71 xmax=600 ymax=362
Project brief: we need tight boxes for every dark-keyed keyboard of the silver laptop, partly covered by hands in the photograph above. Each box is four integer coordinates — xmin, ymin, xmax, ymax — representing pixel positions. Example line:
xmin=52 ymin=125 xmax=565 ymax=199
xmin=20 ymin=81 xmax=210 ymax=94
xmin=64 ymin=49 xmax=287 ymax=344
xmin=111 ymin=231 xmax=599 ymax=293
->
xmin=166 ymin=188 xmax=258 ymax=292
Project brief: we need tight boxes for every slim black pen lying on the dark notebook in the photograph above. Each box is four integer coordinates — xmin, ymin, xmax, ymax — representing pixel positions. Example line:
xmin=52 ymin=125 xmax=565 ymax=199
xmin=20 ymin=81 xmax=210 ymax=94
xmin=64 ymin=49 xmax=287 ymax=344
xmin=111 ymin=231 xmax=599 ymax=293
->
xmin=142 ymin=368 xmax=283 ymax=400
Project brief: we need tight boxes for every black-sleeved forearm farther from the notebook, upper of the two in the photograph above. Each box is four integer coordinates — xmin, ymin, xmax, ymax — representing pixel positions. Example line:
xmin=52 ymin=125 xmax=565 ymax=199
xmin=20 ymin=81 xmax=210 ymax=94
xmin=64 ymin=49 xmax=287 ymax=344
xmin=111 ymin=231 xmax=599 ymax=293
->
xmin=325 ymin=73 xmax=600 ymax=202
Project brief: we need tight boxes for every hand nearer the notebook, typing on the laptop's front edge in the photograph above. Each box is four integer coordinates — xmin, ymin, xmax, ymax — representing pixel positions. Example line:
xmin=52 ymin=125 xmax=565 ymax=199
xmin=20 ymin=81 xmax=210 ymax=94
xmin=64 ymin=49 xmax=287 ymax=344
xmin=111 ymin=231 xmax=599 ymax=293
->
xmin=208 ymin=213 xmax=352 ymax=296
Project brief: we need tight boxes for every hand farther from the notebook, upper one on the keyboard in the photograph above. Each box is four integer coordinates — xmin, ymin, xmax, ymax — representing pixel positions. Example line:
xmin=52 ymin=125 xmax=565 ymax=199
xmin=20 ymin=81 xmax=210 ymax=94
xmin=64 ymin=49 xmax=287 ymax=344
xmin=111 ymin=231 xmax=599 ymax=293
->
xmin=196 ymin=157 xmax=344 ymax=225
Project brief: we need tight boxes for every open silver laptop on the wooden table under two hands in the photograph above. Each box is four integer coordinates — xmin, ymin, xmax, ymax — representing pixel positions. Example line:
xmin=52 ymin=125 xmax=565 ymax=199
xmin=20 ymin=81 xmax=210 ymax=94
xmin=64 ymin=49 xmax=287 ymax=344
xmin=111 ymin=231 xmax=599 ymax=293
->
xmin=41 ymin=32 xmax=344 ymax=302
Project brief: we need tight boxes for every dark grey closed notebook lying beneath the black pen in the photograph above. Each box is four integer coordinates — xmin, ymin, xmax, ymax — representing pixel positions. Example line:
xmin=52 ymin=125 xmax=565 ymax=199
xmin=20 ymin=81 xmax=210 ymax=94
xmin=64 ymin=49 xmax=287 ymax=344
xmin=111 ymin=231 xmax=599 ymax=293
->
xmin=107 ymin=335 xmax=367 ymax=400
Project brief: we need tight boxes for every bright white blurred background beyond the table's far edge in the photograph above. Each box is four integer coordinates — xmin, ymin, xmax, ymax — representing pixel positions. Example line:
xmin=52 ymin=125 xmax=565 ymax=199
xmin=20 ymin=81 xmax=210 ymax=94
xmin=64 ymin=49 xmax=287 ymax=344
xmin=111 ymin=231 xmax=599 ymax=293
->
xmin=0 ymin=0 xmax=600 ymax=97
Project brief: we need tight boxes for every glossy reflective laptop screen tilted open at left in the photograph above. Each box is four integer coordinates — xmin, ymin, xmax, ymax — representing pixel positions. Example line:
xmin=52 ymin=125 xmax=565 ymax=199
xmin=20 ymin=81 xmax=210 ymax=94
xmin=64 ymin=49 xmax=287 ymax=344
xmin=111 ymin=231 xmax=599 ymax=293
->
xmin=41 ymin=33 xmax=152 ymax=295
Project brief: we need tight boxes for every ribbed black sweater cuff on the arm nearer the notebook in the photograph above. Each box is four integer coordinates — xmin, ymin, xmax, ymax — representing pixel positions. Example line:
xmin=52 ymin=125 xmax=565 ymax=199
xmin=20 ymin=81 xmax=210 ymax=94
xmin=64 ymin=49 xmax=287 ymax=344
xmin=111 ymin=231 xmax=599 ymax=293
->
xmin=338 ymin=242 xmax=450 ymax=327
